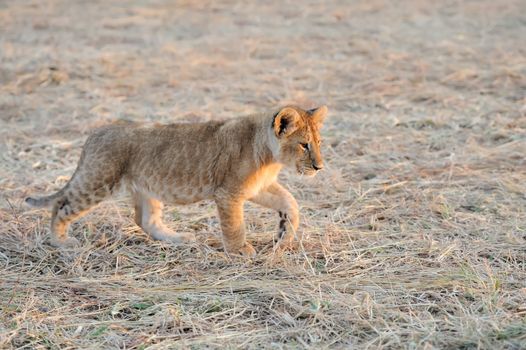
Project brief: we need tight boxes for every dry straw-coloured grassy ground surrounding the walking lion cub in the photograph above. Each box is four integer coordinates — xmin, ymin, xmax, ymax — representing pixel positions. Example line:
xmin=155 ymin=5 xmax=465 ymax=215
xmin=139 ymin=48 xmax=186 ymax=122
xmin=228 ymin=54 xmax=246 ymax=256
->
xmin=0 ymin=0 xmax=526 ymax=349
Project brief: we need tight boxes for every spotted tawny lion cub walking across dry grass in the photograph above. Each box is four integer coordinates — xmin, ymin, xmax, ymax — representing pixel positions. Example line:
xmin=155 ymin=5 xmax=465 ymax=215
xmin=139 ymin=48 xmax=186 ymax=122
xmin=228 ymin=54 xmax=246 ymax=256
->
xmin=26 ymin=106 xmax=327 ymax=256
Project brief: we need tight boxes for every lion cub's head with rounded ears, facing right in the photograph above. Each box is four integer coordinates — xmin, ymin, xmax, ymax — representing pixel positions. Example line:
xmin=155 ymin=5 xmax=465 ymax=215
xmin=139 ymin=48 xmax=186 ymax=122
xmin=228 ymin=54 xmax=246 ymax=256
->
xmin=272 ymin=106 xmax=327 ymax=176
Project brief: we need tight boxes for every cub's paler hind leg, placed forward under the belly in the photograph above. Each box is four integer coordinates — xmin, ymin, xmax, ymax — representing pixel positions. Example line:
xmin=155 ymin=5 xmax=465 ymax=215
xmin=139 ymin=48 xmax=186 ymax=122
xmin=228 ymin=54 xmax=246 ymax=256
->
xmin=133 ymin=193 xmax=195 ymax=243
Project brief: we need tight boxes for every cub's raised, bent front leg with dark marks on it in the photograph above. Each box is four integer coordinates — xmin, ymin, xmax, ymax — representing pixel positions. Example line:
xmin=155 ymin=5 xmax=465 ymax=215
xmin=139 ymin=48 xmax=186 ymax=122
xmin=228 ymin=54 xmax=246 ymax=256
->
xmin=250 ymin=182 xmax=299 ymax=245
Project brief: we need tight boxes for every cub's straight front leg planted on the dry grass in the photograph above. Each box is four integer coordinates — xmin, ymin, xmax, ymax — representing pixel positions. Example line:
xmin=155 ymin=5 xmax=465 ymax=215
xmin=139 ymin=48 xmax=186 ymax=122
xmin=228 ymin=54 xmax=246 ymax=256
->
xmin=215 ymin=196 xmax=256 ymax=257
